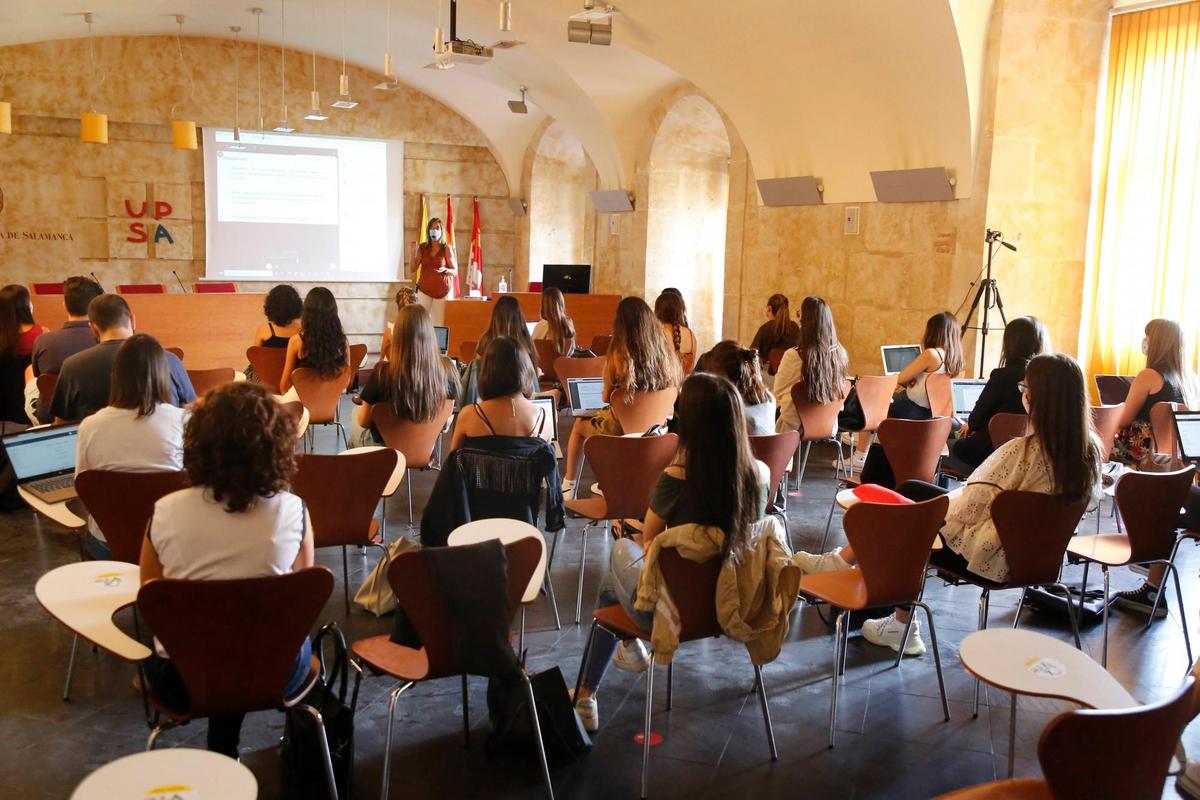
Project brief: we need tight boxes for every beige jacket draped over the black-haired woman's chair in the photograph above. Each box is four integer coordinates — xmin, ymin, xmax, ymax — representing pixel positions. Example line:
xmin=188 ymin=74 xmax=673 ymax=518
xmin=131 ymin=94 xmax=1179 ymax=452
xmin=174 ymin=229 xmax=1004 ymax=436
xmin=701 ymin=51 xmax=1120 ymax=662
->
xmin=635 ymin=517 xmax=800 ymax=666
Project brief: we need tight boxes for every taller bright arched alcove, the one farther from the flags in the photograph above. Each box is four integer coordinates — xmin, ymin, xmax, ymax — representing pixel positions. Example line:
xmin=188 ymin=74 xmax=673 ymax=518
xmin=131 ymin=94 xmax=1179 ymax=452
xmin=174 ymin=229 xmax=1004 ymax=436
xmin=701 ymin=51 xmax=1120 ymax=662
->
xmin=646 ymin=95 xmax=730 ymax=349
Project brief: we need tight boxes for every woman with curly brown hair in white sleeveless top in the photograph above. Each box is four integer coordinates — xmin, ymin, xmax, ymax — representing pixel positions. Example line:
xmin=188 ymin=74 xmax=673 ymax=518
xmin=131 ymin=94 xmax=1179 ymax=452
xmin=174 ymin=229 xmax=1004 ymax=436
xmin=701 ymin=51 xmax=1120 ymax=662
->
xmin=142 ymin=381 xmax=313 ymax=758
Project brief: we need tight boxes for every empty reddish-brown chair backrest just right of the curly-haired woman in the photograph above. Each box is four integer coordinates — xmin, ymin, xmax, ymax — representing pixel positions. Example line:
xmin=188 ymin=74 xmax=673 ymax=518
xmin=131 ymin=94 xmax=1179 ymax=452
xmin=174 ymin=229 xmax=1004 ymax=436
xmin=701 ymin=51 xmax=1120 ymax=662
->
xmin=292 ymin=447 xmax=400 ymax=547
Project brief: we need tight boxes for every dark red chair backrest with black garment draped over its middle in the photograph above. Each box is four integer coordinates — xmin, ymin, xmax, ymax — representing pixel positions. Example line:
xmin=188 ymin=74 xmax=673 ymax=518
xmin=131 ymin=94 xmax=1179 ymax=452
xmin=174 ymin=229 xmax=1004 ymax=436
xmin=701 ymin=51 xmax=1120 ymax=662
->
xmin=388 ymin=539 xmax=540 ymax=680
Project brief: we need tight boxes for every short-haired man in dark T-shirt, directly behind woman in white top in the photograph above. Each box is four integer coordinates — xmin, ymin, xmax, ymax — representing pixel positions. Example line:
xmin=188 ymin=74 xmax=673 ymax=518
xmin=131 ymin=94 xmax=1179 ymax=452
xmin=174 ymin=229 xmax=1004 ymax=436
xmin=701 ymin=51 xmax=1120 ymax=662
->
xmin=50 ymin=294 xmax=196 ymax=422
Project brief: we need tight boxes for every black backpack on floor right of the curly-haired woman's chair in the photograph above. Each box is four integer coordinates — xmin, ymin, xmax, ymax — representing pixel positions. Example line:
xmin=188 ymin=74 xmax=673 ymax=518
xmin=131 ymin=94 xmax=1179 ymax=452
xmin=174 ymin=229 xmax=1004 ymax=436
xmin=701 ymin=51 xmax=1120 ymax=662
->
xmin=280 ymin=622 xmax=362 ymax=800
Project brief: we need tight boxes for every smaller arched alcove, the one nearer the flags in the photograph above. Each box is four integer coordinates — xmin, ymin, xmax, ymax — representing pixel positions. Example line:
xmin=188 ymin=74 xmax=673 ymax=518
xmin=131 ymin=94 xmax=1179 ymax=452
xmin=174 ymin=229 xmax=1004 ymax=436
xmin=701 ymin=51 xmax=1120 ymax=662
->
xmin=529 ymin=122 xmax=596 ymax=282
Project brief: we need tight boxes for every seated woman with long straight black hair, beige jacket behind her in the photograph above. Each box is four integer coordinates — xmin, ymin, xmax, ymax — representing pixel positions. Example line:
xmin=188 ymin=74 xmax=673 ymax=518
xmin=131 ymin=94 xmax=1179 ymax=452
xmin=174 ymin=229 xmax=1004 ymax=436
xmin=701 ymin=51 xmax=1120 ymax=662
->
xmin=575 ymin=373 xmax=770 ymax=730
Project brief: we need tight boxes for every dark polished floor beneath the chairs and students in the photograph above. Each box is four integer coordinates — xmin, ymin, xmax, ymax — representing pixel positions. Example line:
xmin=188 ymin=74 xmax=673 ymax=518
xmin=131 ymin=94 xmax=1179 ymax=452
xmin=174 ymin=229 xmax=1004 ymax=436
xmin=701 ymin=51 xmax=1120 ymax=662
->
xmin=0 ymin=402 xmax=1200 ymax=799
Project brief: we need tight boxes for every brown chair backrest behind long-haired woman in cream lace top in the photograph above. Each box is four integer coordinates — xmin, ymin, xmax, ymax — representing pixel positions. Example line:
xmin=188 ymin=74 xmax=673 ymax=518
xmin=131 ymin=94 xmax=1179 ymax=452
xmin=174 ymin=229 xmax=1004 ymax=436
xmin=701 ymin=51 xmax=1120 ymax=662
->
xmin=991 ymin=489 xmax=1087 ymax=587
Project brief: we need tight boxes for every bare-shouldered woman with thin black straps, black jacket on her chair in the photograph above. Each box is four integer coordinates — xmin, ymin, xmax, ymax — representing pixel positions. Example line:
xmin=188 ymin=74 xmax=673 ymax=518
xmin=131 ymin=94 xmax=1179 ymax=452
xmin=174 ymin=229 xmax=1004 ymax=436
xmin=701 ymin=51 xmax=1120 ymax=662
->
xmin=450 ymin=336 xmax=554 ymax=452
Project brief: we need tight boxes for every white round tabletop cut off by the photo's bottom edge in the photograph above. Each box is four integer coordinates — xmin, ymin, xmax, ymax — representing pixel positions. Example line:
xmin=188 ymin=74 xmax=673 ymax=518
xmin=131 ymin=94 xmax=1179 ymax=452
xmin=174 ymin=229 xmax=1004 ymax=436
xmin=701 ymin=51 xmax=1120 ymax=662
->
xmin=71 ymin=747 xmax=258 ymax=800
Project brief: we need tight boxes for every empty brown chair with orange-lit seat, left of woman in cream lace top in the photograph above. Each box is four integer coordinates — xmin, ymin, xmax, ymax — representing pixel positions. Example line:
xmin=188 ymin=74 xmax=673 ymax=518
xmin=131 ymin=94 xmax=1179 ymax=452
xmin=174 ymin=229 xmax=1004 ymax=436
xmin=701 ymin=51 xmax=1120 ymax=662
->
xmin=800 ymin=497 xmax=950 ymax=747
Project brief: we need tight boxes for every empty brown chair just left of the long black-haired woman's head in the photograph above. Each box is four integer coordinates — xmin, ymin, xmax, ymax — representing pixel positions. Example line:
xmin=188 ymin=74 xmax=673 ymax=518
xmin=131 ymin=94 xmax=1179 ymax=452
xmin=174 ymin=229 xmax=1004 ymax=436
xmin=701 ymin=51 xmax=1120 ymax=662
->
xmin=566 ymin=433 xmax=679 ymax=625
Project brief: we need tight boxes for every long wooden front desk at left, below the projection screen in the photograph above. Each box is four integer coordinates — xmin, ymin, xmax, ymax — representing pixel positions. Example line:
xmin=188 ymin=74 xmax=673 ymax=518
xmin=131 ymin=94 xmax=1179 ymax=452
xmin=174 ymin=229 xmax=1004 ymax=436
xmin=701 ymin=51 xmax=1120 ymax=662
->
xmin=34 ymin=294 xmax=265 ymax=369
